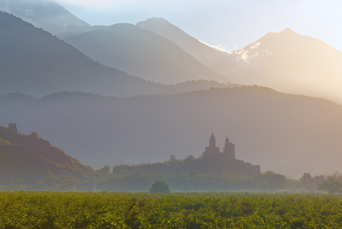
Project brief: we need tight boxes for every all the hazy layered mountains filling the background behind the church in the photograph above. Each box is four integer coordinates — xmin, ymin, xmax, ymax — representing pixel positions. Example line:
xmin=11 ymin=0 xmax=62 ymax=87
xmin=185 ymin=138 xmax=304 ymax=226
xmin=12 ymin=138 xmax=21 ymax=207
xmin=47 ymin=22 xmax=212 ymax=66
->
xmin=0 ymin=0 xmax=342 ymax=176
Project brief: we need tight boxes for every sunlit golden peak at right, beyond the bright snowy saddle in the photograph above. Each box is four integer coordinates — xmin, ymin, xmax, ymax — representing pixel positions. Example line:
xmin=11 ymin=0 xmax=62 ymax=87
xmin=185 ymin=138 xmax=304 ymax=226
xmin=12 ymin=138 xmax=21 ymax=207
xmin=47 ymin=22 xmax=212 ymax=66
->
xmin=237 ymin=29 xmax=342 ymax=103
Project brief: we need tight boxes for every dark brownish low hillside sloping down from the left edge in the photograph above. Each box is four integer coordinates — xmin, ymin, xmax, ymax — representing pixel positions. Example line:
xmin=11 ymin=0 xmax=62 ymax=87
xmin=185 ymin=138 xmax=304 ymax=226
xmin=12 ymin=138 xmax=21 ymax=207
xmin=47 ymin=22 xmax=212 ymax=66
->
xmin=0 ymin=127 xmax=94 ymax=185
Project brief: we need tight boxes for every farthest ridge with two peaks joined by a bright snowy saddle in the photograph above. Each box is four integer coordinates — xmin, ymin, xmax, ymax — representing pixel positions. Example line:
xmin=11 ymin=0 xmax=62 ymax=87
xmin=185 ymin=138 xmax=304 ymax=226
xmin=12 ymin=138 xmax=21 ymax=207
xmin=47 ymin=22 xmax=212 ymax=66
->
xmin=137 ymin=18 xmax=342 ymax=104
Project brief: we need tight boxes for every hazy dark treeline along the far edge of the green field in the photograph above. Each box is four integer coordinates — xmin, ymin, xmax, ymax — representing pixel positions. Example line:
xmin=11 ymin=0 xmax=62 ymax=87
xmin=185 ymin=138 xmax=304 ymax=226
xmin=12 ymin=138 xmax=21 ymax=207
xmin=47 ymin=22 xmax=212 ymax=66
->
xmin=0 ymin=156 xmax=342 ymax=194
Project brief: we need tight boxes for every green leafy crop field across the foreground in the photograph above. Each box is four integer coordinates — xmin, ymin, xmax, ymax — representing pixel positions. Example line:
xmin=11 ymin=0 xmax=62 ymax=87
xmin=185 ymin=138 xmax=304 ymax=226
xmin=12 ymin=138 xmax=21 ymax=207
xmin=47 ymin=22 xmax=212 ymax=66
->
xmin=0 ymin=192 xmax=342 ymax=229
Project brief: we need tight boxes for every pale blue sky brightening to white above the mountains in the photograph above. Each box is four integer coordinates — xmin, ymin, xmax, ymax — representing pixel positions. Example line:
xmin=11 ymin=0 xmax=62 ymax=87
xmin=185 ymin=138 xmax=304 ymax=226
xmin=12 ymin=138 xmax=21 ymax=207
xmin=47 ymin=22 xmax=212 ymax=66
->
xmin=57 ymin=0 xmax=342 ymax=51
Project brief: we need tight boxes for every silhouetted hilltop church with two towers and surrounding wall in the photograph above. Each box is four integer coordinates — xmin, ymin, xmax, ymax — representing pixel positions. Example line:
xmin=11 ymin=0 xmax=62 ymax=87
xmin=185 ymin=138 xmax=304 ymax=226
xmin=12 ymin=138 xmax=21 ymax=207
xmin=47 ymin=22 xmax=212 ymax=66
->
xmin=203 ymin=134 xmax=260 ymax=176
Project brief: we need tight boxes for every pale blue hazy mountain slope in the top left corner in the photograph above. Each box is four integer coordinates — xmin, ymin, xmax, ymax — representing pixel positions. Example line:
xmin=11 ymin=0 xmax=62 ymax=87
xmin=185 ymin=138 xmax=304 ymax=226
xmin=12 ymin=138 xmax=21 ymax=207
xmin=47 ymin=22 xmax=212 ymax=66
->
xmin=0 ymin=0 xmax=89 ymax=33
